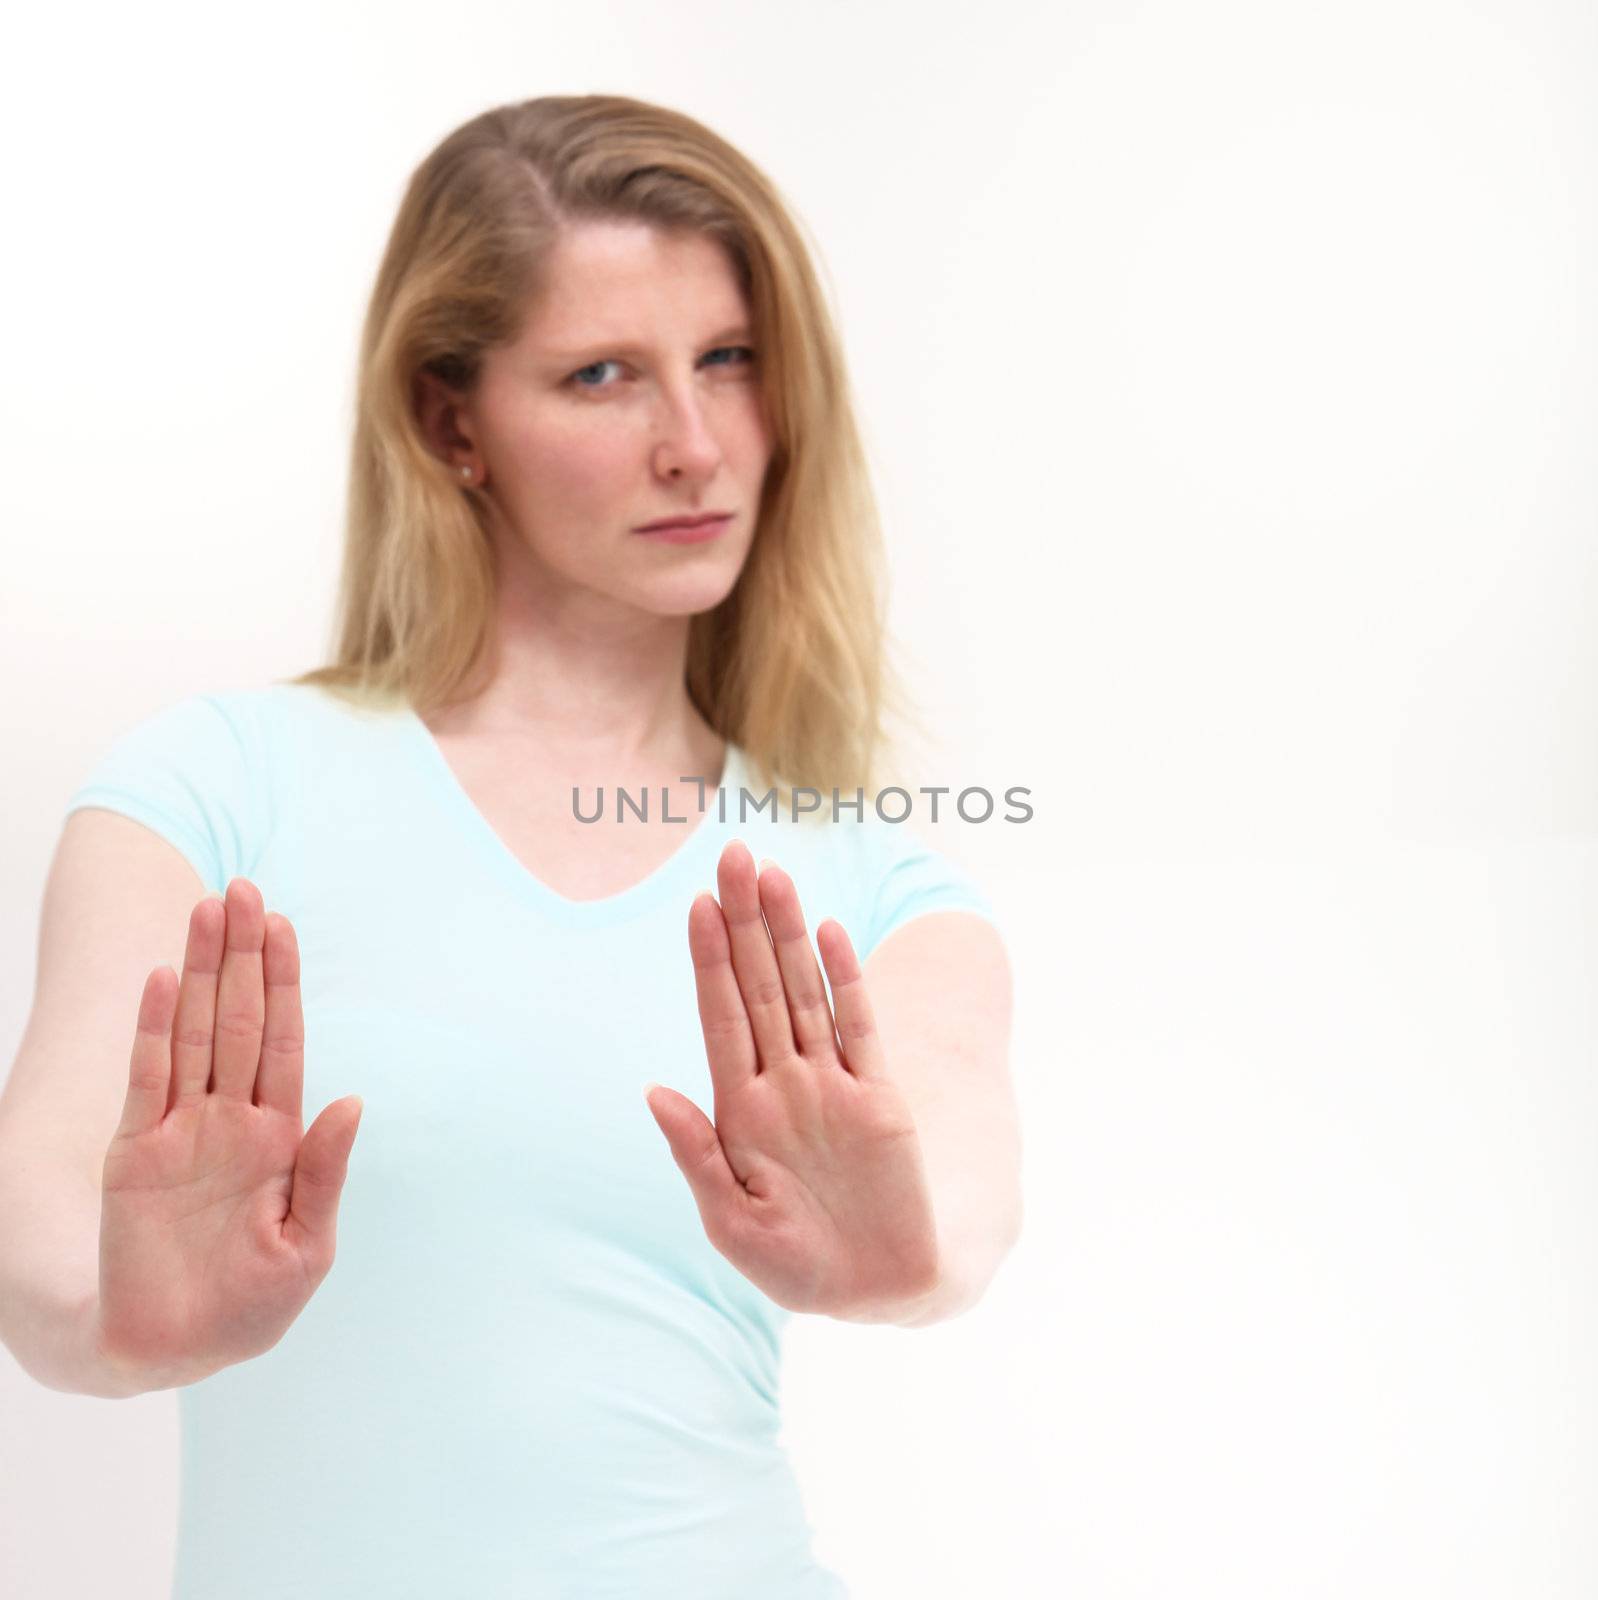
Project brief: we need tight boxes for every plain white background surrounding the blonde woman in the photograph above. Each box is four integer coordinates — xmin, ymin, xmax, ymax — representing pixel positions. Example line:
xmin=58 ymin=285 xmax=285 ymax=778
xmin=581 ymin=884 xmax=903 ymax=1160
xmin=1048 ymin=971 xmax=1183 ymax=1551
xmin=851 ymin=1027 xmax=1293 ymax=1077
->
xmin=0 ymin=0 xmax=1598 ymax=1600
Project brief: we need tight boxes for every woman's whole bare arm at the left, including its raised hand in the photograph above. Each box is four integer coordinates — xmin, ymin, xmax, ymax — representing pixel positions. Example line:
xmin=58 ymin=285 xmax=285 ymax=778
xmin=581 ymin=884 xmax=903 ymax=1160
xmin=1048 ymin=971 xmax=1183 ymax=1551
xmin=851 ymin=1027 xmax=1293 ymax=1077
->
xmin=0 ymin=814 xmax=360 ymax=1397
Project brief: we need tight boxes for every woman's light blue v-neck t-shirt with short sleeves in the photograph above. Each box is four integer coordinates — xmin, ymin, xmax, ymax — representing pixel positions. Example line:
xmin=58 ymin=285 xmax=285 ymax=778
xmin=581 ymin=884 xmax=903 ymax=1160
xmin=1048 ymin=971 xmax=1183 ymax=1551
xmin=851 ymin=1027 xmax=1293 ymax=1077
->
xmin=67 ymin=683 xmax=993 ymax=1600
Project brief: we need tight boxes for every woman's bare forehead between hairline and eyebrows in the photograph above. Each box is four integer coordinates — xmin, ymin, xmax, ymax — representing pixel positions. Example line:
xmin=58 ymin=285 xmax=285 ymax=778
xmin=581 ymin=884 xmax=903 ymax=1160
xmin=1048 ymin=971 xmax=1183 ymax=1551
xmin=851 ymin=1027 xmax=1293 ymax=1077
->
xmin=521 ymin=221 xmax=749 ymax=347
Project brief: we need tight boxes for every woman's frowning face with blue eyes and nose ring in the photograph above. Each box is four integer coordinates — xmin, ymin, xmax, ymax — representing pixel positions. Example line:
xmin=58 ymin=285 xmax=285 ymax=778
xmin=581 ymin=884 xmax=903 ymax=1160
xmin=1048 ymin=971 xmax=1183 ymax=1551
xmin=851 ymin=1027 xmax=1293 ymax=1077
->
xmin=435 ymin=221 xmax=771 ymax=616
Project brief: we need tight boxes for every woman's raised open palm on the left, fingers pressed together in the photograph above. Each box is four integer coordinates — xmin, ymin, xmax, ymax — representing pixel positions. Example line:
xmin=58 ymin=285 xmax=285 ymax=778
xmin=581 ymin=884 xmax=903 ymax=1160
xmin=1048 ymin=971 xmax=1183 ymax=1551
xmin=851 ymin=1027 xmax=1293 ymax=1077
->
xmin=96 ymin=878 xmax=362 ymax=1389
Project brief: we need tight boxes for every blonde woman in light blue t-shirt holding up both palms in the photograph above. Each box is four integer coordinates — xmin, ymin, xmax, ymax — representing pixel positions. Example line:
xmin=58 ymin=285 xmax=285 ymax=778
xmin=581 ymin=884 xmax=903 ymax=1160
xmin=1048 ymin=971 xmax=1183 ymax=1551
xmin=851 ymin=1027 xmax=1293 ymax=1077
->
xmin=0 ymin=96 xmax=1021 ymax=1600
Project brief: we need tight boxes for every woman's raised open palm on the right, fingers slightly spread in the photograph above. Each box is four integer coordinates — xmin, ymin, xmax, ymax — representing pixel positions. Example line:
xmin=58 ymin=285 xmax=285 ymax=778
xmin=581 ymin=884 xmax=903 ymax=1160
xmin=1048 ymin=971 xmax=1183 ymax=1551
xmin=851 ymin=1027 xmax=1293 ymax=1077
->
xmin=648 ymin=842 xmax=939 ymax=1322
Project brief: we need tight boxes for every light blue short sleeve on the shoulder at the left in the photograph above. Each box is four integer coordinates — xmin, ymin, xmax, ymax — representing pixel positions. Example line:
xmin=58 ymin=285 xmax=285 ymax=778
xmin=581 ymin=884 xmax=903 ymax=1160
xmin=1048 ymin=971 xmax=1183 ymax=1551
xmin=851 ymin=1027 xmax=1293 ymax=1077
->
xmin=67 ymin=694 xmax=261 ymax=894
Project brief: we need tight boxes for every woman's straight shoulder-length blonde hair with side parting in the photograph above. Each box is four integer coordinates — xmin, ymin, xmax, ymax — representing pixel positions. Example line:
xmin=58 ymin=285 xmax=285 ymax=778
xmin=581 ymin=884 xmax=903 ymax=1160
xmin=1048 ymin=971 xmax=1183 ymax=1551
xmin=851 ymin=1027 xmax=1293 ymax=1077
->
xmin=286 ymin=94 xmax=920 ymax=806
